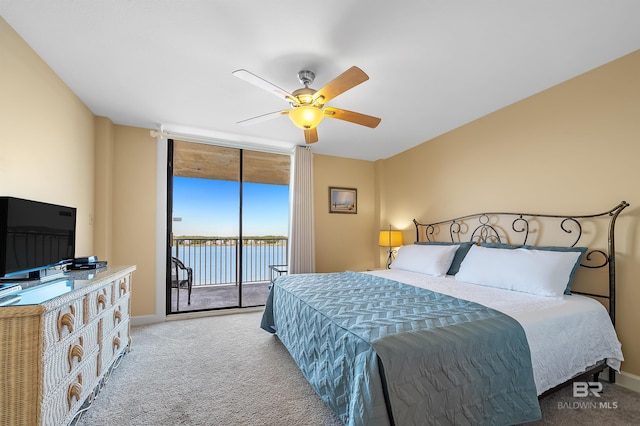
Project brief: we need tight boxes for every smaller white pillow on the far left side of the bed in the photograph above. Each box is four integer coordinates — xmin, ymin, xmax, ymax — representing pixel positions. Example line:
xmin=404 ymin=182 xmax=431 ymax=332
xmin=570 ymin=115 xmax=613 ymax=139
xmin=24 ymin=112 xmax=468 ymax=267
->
xmin=391 ymin=244 xmax=460 ymax=277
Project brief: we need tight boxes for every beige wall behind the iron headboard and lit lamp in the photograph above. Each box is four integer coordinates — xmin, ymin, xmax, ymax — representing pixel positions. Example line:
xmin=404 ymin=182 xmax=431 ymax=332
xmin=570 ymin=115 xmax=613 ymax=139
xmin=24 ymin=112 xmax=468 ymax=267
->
xmin=378 ymin=51 xmax=640 ymax=375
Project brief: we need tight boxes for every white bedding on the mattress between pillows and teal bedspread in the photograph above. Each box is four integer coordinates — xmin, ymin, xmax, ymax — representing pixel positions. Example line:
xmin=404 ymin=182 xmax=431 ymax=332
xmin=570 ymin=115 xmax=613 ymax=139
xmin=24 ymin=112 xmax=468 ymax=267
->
xmin=367 ymin=269 xmax=624 ymax=395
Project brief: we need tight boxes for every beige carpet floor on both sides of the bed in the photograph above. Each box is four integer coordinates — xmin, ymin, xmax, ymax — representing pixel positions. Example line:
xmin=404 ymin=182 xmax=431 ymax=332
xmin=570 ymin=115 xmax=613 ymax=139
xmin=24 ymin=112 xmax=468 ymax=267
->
xmin=77 ymin=312 xmax=640 ymax=426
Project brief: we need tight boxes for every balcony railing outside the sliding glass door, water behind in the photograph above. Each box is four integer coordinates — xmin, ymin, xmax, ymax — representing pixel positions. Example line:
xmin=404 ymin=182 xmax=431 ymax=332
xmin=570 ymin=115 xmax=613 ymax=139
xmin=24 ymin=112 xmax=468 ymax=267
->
xmin=171 ymin=237 xmax=288 ymax=287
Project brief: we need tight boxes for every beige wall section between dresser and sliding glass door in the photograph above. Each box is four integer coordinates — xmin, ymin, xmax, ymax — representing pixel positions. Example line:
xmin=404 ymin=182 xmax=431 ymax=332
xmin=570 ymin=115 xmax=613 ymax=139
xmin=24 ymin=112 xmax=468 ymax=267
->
xmin=93 ymin=117 xmax=158 ymax=317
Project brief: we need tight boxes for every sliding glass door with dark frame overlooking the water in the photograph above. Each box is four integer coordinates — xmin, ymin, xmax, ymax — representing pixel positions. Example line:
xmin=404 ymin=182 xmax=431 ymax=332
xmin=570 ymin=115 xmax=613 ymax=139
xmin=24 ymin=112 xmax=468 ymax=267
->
xmin=167 ymin=141 xmax=290 ymax=313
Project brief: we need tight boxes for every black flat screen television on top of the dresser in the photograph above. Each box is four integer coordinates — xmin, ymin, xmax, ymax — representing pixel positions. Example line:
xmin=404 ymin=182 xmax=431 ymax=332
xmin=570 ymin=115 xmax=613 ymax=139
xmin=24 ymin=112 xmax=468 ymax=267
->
xmin=0 ymin=197 xmax=76 ymax=279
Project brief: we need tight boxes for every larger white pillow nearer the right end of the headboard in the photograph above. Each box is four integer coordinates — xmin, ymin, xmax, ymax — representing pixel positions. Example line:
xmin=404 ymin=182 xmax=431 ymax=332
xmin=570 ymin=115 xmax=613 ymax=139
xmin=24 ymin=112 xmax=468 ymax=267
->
xmin=455 ymin=246 xmax=582 ymax=297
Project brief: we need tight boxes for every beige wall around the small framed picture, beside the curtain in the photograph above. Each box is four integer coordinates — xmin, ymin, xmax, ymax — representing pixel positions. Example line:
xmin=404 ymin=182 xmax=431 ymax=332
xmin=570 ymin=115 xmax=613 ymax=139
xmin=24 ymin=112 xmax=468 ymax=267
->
xmin=313 ymin=154 xmax=379 ymax=272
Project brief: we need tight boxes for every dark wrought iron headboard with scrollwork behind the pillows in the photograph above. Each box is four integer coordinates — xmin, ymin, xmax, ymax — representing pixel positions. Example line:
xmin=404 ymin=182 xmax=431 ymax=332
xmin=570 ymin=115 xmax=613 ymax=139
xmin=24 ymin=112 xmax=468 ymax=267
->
xmin=413 ymin=201 xmax=629 ymax=325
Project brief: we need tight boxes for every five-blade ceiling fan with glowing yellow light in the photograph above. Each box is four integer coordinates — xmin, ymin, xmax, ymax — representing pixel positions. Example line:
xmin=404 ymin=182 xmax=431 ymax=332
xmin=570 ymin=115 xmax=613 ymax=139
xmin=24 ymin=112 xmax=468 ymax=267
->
xmin=232 ymin=67 xmax=381 ymax=144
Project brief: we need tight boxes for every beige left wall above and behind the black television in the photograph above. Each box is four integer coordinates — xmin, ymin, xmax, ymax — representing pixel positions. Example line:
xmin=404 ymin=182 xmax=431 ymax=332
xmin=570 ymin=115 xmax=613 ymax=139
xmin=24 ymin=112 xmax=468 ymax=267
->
xmin=0 ymin=17 xmax=94 ymax=256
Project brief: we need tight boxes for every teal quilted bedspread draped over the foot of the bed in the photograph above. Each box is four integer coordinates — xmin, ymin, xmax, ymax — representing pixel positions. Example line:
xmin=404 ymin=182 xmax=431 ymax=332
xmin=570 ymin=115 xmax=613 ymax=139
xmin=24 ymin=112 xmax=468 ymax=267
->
xmin=261 ymin=272 xmax=541 ymax=425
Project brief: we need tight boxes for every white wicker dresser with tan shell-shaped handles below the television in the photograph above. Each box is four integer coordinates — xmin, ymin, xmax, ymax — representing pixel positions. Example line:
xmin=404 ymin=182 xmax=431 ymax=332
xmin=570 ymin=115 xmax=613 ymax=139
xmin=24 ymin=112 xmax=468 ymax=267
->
xmin=0 ymin=266 xmax=136 ymax=426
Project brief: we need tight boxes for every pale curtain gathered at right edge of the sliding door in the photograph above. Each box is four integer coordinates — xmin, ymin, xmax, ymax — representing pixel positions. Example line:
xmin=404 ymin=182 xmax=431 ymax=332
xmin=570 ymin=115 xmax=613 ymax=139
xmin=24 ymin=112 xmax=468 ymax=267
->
xmin=288 ymin=146 xmax=316 ymax=274
